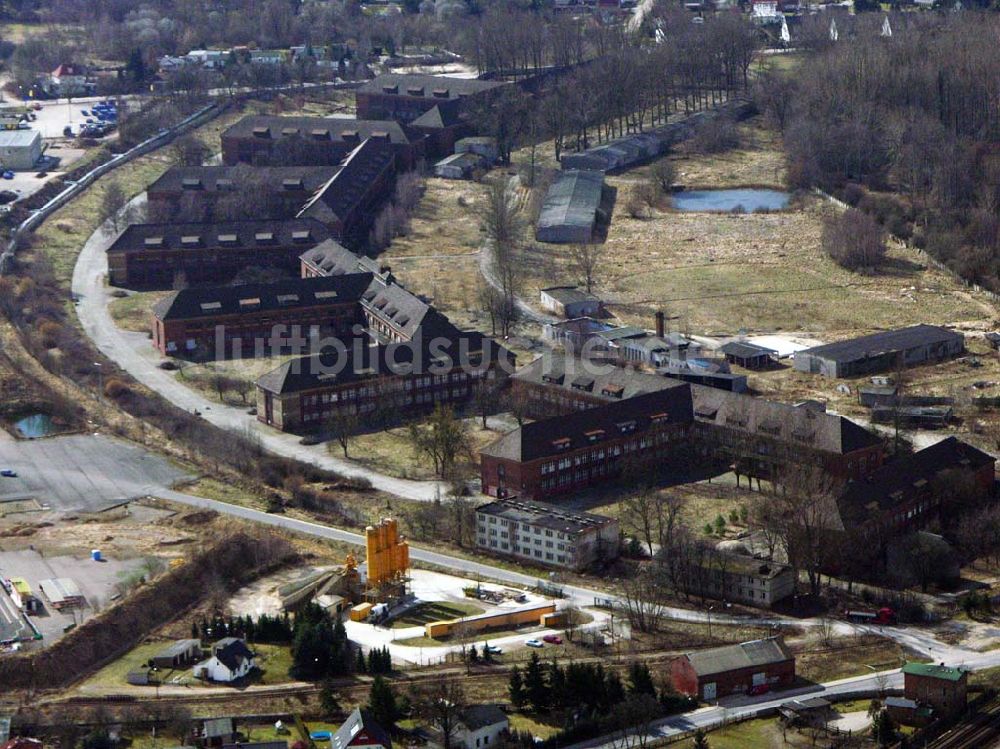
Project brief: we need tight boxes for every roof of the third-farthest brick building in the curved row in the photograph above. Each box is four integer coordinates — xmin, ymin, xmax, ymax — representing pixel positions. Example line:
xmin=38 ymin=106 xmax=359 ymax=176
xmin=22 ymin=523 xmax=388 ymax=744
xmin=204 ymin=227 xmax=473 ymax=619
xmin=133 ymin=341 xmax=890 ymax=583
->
xmin=146 ymin=164 xmax=341 ymax=196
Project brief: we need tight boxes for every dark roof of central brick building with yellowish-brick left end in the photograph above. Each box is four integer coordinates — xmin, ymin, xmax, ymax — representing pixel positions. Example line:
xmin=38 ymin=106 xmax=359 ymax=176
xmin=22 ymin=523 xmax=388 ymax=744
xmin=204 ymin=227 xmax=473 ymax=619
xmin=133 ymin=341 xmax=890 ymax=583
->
xmin=257 ymin=331 xmax=508 ymax=395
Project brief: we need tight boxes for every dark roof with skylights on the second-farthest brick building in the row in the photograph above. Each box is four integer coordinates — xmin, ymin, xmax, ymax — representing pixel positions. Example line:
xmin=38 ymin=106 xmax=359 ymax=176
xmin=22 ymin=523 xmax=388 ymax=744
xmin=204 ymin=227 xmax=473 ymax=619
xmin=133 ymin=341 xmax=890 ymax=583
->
xmin=222 ymin=115 xmax=410 ymax=145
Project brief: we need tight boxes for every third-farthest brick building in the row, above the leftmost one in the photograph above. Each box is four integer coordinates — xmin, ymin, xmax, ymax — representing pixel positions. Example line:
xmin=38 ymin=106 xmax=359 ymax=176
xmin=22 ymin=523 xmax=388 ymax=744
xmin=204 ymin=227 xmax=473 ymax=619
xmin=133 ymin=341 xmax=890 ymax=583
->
xmin=146 ymin=164 xmax=340 ymax=221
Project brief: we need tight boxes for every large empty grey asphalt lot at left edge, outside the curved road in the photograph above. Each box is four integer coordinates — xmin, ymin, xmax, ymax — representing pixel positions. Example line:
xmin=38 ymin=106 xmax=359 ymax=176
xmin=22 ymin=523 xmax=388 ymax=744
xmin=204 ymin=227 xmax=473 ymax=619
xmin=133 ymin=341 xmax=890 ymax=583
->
xmin=0 ymin=434 xmax=195 ymax=515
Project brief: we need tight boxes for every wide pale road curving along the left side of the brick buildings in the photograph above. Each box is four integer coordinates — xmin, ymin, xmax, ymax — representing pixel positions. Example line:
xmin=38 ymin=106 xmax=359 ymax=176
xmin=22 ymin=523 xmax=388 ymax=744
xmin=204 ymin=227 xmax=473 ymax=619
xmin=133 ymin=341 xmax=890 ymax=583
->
xmin=72 ymin=202 xmax=448 ymax=501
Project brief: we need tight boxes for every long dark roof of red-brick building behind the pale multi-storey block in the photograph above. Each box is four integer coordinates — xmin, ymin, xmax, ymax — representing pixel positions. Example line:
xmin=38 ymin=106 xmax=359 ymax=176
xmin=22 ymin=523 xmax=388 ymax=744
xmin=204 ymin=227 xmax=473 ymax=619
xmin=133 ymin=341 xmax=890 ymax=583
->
xmin=481 ymin=382 xmax=692 ymax=462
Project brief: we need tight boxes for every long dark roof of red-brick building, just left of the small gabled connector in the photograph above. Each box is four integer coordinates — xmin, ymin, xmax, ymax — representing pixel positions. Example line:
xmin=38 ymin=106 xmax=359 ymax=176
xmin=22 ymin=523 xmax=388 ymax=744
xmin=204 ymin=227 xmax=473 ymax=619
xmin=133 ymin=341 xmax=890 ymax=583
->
xmin=153 ymin=273 xmax=372 ymax=320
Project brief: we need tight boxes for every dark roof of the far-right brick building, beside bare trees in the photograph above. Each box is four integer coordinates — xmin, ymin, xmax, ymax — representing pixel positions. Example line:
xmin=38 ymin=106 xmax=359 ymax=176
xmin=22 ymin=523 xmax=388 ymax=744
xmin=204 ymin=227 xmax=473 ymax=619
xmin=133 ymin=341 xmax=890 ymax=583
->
xmin=837 ymin=436 xmax=995 ymax=522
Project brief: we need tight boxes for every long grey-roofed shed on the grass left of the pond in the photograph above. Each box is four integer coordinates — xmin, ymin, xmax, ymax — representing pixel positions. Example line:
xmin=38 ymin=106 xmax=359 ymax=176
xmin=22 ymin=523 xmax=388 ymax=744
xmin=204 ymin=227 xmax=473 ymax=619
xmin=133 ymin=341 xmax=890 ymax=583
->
xmin=535 ymin=169 xmax=604 ymax=244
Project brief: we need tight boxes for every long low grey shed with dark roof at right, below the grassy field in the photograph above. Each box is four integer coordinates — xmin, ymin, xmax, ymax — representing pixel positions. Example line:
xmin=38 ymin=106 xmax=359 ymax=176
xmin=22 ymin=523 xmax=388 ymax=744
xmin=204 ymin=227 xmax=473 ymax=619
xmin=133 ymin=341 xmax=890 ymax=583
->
xmin=795 ymin=325 xmax=965 ymax=377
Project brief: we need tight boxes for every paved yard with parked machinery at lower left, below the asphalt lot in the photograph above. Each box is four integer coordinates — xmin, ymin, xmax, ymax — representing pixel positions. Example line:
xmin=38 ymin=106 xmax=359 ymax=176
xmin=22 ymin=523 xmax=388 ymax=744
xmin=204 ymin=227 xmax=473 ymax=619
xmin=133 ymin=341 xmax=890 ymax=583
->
xmin=0 ymin=549 xmax=143 ymax=646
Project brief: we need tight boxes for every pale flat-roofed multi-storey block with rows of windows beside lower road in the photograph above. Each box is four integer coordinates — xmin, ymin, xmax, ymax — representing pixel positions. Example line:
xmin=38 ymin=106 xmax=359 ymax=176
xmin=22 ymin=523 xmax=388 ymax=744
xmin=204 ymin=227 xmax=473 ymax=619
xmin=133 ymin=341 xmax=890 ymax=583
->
xmin=476 ymin=498 xmax=621 ymax=570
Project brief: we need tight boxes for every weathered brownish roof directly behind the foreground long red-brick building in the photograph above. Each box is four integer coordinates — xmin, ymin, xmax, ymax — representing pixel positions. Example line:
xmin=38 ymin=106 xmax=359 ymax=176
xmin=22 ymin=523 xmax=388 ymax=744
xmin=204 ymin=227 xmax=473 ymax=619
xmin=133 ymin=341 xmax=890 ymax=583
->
xmin=513 ymin=353 xmax=681 ymax=402
